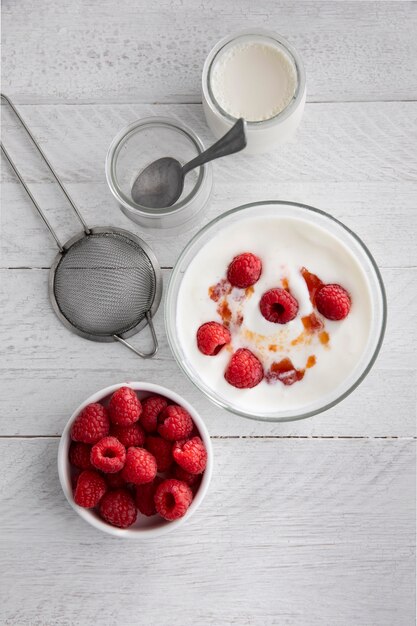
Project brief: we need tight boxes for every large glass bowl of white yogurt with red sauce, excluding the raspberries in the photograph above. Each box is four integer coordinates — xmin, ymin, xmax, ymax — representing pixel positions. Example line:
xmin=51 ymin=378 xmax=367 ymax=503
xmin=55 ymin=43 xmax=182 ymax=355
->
xmin=165 ymin=201 xmax=386 ymax=421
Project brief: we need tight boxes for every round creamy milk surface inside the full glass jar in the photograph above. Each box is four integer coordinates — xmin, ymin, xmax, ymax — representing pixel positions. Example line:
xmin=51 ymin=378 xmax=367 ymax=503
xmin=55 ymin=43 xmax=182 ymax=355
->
xmin=211 ymin=40 xmax=297 ymax=122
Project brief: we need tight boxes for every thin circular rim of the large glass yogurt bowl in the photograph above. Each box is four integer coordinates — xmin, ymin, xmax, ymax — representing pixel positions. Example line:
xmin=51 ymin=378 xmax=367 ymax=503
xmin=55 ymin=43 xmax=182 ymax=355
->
xmin=164 ymin=200 xmax=387 ymax=423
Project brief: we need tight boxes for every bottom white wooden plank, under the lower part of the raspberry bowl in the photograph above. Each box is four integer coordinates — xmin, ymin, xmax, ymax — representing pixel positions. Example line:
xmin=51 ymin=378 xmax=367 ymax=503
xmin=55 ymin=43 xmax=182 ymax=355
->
xmin=0 ymin=439 xmax=415 ymax=626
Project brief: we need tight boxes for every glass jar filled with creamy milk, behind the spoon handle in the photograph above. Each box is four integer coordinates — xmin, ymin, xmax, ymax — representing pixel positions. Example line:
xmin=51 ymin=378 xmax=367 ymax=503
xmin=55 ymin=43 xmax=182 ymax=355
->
xmin=202 ymin=30 xmax=306 ymax=154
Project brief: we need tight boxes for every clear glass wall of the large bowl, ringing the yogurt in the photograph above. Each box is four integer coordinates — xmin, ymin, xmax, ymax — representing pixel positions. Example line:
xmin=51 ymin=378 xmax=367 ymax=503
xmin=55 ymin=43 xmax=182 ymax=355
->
xmin=165 ymin=201 xmax=386 ymax=421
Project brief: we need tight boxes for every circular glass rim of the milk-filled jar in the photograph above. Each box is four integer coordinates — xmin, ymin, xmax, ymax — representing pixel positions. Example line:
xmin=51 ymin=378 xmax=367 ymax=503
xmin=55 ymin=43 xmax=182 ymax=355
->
xmin=202 ymin=28 xmax=306 ymax=130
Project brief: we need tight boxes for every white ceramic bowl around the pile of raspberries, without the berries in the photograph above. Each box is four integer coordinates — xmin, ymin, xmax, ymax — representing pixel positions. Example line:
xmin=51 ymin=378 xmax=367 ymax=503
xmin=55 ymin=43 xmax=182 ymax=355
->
xmin=58 ymin=382 xmax=213 ymax=539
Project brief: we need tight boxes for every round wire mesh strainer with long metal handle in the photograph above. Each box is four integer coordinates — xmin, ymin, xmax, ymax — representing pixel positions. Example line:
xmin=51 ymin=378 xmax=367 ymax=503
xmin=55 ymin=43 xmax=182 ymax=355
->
xmin=1 ymin=94 xmax=162 ymax=358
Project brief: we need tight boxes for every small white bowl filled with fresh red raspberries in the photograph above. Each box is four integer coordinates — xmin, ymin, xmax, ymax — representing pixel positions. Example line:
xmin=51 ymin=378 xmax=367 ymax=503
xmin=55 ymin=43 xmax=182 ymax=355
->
xmin=58 ymin=382 xmax=213 ymax=538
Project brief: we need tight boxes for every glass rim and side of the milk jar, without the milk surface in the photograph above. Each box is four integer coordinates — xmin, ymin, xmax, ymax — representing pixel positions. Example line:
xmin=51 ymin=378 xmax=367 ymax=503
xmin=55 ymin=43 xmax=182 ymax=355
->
xmin=202 ymin=30 xmax=306 ymax=154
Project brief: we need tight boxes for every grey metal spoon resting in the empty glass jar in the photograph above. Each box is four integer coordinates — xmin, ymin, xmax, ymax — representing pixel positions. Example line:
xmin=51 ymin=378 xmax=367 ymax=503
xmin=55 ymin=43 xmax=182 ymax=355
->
xmin=132 ymin=118 xmax=246 ymax=209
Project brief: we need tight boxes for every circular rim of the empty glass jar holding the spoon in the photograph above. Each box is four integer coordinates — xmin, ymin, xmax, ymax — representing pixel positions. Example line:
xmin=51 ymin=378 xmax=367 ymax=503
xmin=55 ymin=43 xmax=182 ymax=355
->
xmin=105 ymin=115 xmax=211 ymax=220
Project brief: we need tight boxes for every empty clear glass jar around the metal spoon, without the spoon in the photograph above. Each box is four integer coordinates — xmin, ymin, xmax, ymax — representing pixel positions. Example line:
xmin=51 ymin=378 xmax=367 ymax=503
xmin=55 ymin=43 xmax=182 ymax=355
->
xmin=106 ymin=117 xmax=213 ymax=232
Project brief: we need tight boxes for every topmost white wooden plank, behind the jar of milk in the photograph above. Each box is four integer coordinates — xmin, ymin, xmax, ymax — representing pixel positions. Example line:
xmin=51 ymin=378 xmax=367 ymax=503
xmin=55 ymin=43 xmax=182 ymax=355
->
xmin=3 ymin=0 xmax=417 ymax=102
